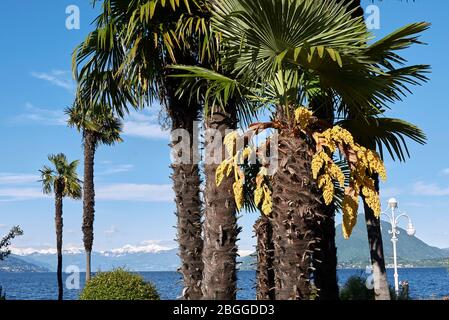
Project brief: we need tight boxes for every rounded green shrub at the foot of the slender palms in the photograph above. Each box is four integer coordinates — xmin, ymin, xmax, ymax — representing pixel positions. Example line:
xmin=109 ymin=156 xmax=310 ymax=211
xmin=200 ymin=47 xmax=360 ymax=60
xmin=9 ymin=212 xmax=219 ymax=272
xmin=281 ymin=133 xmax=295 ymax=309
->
xmin=80 ymin=269 xmax=159 ymax=300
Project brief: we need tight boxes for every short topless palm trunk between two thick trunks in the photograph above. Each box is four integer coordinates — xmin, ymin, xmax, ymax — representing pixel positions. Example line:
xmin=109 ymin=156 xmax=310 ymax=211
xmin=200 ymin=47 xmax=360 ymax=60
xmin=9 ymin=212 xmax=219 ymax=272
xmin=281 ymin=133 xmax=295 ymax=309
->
xmin=254 ymin=215 xmax=276 ymax=300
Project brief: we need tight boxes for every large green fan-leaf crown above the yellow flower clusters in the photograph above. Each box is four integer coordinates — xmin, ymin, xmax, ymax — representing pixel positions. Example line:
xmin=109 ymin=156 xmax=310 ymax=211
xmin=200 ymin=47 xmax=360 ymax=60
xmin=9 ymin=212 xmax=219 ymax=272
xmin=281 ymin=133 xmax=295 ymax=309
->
xmin=173 ymin=0 xmax=428 ymax=122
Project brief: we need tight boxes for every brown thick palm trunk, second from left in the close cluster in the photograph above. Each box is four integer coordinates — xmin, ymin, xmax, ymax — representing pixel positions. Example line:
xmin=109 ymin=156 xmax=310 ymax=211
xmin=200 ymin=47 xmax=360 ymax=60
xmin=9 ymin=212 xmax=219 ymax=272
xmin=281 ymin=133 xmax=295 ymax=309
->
xmin=202 ymin=108 xmax=240 ymax=300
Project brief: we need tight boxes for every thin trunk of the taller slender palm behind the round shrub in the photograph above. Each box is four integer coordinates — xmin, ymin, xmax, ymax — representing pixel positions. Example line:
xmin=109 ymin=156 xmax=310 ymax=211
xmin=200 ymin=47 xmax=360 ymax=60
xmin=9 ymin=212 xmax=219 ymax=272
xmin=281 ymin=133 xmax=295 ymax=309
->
xmin=82 ymin=131 xmax=96 ymax=283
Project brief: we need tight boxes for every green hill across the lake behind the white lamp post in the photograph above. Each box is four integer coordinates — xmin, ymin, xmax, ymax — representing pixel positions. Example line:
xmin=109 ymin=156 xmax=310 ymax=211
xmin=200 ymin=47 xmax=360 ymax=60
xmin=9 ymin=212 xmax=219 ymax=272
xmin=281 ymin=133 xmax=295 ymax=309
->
xmin=241 ymin=215 xmax=449 ymax=270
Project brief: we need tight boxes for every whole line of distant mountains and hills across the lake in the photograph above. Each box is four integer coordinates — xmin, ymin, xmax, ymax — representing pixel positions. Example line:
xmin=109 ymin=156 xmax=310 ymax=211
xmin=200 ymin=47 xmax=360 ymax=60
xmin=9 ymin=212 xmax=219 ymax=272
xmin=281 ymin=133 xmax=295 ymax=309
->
xmin=7 ymin=216 xmax=449 ymax=271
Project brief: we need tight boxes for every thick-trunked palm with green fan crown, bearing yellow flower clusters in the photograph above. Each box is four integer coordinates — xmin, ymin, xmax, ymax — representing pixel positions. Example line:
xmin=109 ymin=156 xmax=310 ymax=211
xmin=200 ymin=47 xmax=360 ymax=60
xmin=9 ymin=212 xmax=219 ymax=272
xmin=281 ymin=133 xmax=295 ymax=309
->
xmin=176 ymin=0 xmax=427 ymax=299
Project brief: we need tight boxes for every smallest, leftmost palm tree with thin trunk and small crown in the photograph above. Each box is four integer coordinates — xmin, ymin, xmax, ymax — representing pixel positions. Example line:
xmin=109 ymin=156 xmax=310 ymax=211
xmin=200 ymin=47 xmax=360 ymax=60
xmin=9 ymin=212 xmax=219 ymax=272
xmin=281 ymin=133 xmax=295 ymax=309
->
xmin=39 ymin=153 xmax=82 ymax=300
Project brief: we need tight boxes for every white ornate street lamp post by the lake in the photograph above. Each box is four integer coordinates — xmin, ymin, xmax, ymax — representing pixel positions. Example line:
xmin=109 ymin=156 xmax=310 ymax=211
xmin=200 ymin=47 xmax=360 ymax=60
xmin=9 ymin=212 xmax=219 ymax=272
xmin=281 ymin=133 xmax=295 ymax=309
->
xmin=382 ymin=198 xmax=416 ymax=296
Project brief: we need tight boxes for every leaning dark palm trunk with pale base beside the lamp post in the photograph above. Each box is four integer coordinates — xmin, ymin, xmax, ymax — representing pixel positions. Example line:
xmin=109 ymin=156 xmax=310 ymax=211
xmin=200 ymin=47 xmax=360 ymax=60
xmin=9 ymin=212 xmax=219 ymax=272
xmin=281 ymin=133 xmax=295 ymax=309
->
xmin=362 ymin=175 xmax=391 ymax=300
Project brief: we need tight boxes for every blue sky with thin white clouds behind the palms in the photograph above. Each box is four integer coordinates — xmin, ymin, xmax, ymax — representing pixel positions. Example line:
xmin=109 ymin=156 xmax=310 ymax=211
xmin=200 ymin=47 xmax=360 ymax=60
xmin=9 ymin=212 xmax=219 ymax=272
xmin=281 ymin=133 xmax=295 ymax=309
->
xmin=0 ymin=0 xmax=449 ymax=255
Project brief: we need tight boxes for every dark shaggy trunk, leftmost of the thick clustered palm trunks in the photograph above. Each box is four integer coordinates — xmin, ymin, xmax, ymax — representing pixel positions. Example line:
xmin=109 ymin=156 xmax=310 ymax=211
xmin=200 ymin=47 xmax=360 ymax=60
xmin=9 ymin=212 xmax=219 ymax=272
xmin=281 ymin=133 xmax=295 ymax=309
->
xmin=162 ymin=68 xmax=203 ymax=300
